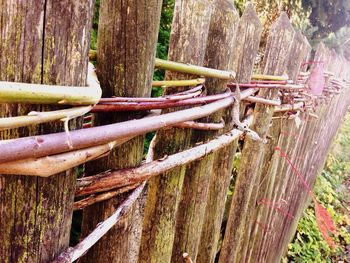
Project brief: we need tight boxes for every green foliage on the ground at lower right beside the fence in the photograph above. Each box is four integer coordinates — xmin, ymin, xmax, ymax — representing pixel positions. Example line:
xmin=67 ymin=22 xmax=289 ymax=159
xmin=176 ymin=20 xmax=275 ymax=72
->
xmin=284 ymin=113 xmax=350 ymax=262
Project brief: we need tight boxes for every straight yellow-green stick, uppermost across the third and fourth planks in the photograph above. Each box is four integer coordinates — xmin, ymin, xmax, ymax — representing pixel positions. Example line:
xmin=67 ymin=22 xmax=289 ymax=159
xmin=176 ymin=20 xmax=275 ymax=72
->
xmin=155 ymin=58 xmax=236 ymax=79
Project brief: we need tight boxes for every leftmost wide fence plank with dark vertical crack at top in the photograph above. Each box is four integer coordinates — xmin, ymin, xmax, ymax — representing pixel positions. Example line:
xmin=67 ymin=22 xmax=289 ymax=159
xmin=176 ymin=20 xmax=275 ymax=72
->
xmin=0 ymin=0 xmax=94 ymax=262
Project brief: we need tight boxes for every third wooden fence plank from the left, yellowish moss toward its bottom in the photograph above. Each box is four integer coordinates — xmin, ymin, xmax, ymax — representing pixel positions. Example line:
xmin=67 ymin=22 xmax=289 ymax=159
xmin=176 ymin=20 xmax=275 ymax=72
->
xmin=139 ymin=0 xmax=212 ymax=262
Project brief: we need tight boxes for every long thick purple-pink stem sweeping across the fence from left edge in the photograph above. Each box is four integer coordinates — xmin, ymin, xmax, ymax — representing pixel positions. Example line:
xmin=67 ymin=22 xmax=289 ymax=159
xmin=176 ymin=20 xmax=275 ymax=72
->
xmin=0 ymin=97 xmax=239 ymax=163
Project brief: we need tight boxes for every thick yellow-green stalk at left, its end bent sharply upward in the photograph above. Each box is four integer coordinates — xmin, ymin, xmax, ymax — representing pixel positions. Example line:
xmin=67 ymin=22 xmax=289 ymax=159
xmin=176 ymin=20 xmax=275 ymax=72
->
xmin=0 ymin=63 xmax=102 ymax=105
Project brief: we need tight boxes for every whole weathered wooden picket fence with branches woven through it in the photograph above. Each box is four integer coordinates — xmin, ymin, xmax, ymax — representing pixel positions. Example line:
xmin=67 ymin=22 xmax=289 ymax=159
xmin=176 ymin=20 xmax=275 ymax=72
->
xmin=0 ymin=0 xmax=350 ymax=263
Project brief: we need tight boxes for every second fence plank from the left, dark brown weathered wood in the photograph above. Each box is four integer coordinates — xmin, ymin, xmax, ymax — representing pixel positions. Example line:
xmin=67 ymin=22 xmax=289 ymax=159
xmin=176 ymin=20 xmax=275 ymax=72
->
xmin=82 ymin=0 xmax=162 ymax=263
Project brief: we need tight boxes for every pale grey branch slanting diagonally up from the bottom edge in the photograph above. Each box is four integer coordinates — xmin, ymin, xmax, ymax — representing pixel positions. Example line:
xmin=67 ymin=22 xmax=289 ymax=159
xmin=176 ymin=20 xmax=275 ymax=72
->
xmin=54 ymin=184 xmax=145 ymax=263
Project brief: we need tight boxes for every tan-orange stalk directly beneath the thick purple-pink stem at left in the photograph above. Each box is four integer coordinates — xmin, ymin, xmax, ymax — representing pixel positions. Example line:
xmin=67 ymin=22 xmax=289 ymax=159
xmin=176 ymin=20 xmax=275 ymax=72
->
xmin=0 ymin=138 xmax=132 ymax=177
